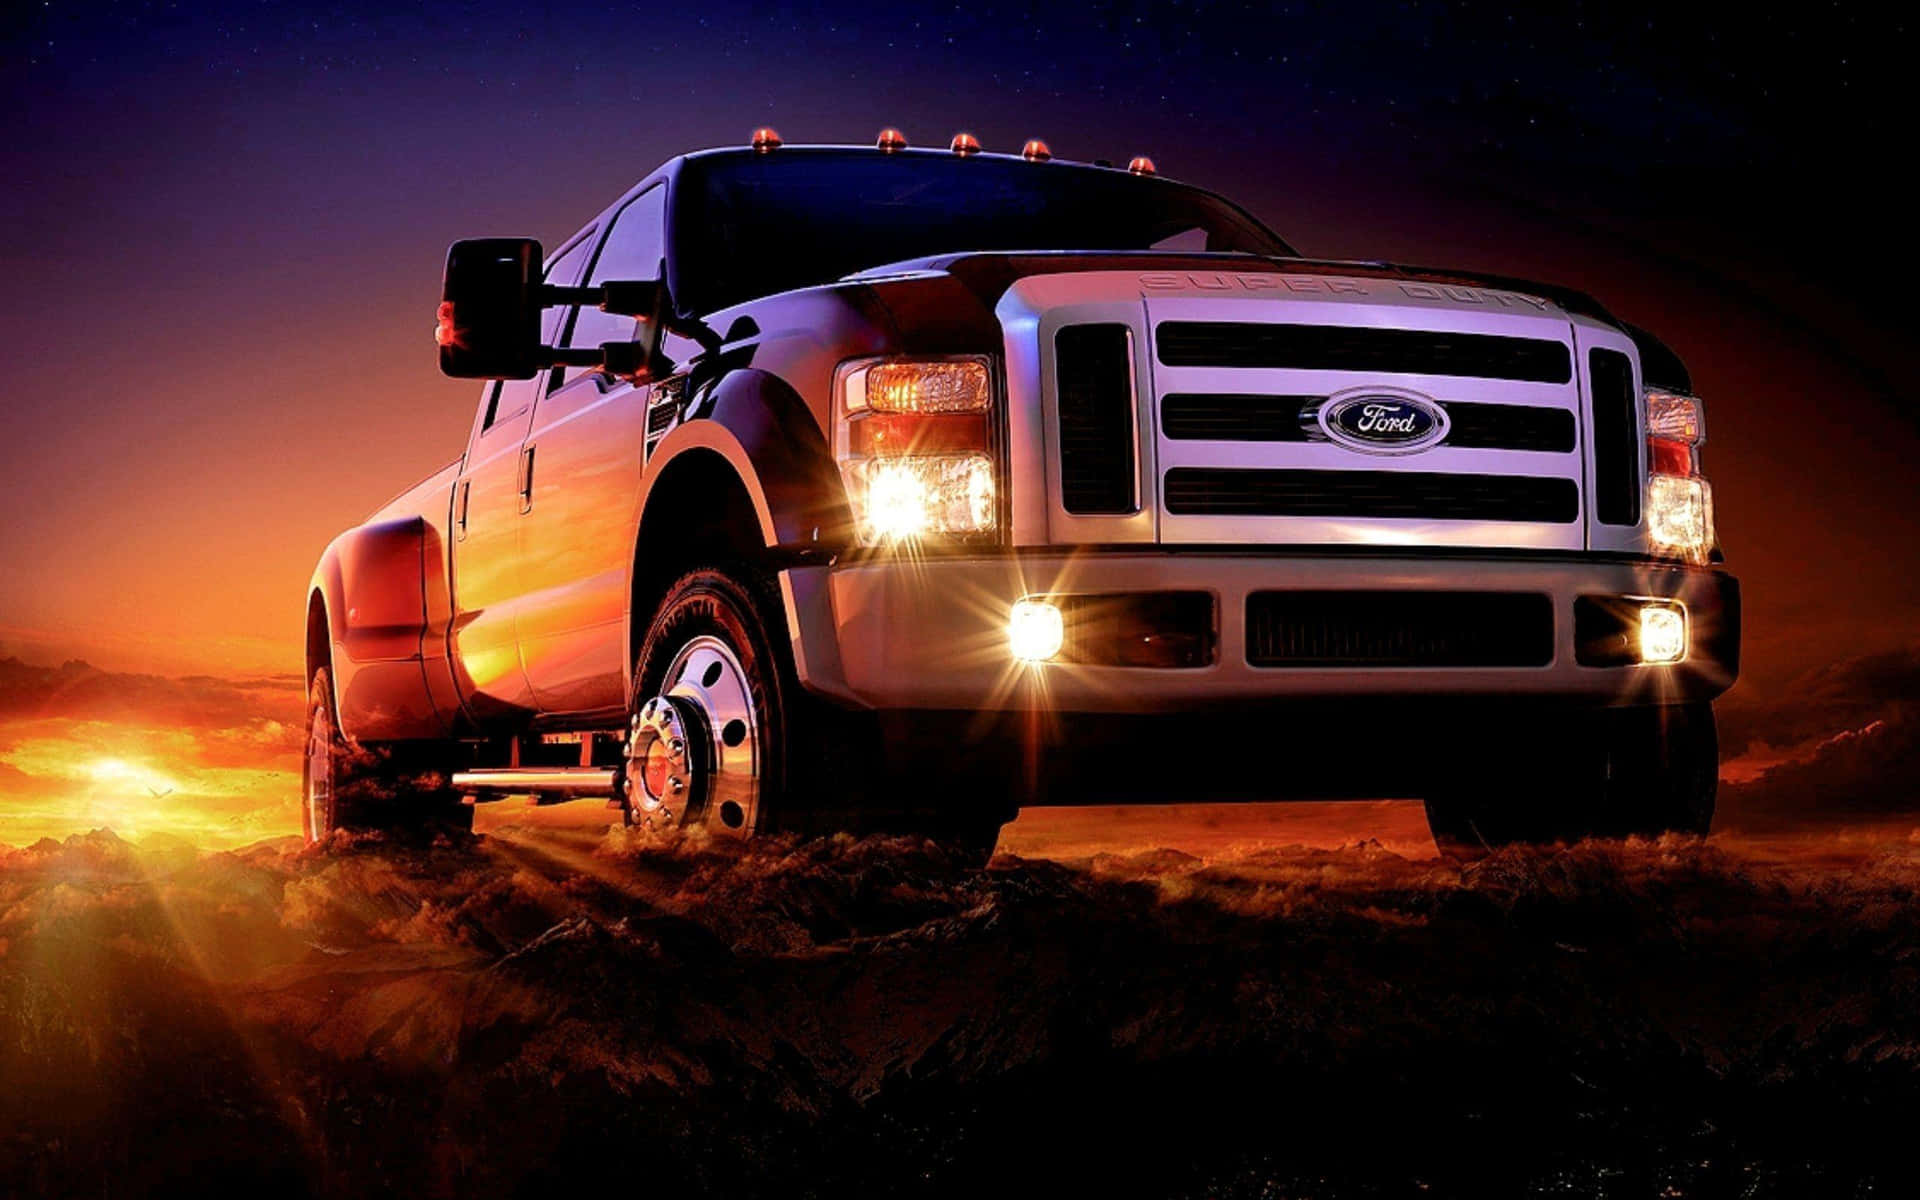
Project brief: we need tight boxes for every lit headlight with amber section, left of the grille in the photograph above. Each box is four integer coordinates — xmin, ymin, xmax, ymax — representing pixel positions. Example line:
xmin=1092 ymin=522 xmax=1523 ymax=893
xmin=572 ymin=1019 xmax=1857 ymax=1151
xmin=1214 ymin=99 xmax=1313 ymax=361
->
xmin=833 ymin=357 xmax=1000 ymax=545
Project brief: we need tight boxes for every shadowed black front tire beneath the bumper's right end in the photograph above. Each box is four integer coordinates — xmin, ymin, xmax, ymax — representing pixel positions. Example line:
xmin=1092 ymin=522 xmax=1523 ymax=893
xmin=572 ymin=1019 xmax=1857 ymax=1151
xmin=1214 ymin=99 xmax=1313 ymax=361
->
xmin=1427 ymin=705 xmax=1720 ymax=856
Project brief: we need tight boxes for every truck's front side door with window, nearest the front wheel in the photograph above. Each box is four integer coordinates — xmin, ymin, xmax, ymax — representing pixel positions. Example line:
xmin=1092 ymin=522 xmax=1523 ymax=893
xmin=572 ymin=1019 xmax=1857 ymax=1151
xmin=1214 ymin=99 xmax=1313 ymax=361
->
xmin=520 ymin=184 xmax=666 ymax=714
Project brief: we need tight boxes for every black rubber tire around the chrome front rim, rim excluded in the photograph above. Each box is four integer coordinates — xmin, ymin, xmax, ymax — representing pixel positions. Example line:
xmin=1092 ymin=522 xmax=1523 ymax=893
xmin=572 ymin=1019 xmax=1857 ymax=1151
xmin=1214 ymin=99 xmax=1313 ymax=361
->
xmin=626 ymin=564 xmax=1004 ymax=864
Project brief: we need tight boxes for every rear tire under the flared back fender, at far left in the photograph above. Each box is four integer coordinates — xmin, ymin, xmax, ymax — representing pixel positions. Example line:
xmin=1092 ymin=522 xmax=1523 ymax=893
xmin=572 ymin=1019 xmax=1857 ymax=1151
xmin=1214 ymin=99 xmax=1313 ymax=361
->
xmin=300 ymin=666 xmax=474 ymax=845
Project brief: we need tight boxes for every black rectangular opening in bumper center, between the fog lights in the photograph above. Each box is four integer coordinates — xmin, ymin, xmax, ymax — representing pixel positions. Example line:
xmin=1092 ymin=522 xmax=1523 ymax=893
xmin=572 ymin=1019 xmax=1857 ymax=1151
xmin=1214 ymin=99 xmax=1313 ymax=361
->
xmin=1246 ymin=591 xmax=1553 ymax=668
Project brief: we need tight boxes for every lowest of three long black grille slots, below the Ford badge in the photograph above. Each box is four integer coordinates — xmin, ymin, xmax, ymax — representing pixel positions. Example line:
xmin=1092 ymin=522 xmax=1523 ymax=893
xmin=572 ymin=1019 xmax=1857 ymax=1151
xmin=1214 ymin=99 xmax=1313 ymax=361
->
xmin=1164 ymin=467 xmax=1580 ymax=524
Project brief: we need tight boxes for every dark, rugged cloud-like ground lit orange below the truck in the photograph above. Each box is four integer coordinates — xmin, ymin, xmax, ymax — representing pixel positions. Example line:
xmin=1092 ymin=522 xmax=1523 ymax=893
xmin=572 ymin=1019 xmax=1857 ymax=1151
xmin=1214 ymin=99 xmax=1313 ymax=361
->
xmin=0 ymin=810 xmax=1920 ymax=1196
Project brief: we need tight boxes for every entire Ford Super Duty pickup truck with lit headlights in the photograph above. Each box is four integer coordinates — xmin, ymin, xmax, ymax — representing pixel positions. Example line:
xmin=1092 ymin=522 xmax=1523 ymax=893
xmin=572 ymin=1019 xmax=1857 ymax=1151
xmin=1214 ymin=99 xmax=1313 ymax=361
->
xmin=303 ymin=129 xmax=1740 ymax=862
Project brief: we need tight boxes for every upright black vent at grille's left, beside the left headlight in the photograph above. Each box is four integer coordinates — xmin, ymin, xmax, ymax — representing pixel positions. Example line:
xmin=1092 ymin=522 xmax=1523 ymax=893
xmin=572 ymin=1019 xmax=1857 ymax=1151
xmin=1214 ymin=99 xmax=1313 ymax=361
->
xmin=1054 ymin=324 xmax=1140 ymax=516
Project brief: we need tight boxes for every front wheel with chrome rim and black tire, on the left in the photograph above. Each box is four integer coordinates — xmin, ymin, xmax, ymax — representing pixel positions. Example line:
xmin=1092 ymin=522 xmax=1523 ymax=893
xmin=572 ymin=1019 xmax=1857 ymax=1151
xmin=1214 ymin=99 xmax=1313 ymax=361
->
xmin=626 ymin=566 xmax=1000 ymax=864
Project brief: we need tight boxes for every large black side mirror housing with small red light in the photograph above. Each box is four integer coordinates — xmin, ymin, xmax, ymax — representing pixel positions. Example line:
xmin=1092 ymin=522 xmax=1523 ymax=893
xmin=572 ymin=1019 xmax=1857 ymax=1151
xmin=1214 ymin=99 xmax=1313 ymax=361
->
xmin=434 ymin=238 xmax=547 ymax=378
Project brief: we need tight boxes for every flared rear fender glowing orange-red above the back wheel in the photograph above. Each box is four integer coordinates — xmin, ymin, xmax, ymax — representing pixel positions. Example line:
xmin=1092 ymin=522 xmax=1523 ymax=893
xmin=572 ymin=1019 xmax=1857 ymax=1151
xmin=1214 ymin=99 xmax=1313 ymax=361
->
xmin=307 ymin=516 xmax=449 ymax=741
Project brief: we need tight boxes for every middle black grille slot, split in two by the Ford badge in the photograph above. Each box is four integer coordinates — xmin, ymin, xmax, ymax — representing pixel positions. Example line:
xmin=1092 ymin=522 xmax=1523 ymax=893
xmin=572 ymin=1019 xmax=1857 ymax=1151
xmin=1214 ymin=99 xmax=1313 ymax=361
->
xmin=1160 ymin=392 xmax=1578 ymax=453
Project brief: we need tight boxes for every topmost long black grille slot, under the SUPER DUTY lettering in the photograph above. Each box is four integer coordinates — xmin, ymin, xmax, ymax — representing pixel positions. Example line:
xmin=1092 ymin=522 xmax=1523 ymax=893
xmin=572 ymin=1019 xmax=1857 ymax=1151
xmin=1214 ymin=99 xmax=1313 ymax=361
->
xmin=1156 ymin=321 xmax=1572 ymax=384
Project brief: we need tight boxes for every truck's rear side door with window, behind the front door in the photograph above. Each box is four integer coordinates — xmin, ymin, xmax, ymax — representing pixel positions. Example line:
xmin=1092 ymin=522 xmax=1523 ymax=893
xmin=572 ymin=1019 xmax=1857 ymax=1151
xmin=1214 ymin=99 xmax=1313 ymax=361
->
xmin=449 ymin=230 xmax=593 ymax=722
